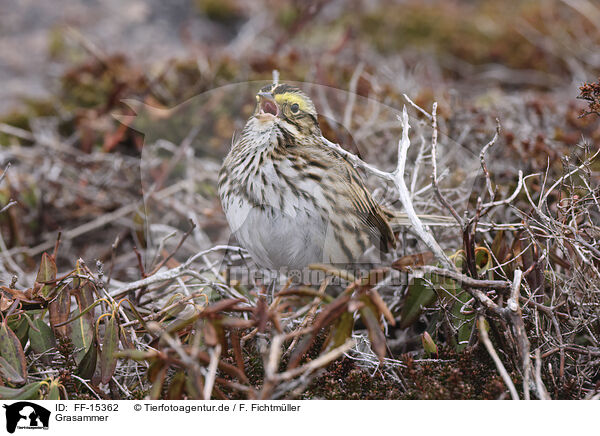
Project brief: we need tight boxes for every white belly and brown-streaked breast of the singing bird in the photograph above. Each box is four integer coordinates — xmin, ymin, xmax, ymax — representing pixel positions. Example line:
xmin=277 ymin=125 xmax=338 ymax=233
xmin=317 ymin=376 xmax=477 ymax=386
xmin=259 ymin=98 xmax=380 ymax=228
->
xmin=220 ymin=120 xmax=360 ymax=269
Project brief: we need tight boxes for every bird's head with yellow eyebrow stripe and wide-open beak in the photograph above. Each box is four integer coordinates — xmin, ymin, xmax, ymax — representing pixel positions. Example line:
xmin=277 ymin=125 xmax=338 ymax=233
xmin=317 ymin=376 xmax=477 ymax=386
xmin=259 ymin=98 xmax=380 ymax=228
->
xmin=254 ymin=83 xmax=320 ymax=134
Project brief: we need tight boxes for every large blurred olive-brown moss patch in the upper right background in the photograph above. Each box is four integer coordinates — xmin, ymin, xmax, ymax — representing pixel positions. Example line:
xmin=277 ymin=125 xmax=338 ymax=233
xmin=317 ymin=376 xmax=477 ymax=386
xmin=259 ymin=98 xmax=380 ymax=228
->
xmin=355 ymin=1 xmax=567 ymax=77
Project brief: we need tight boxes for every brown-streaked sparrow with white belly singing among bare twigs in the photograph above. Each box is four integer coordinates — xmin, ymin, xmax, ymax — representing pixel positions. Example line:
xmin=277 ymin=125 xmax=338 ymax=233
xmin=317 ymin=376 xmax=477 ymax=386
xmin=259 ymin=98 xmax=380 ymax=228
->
xmin=218 ymin=83 xmax=434 ymax=270
